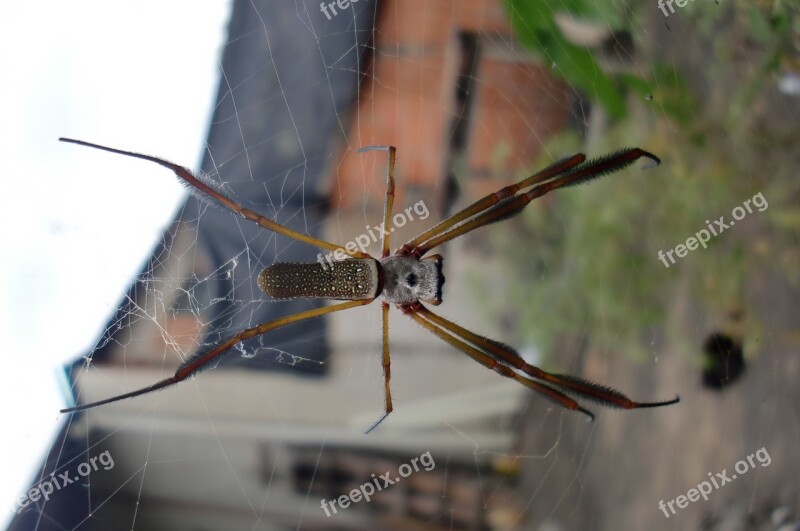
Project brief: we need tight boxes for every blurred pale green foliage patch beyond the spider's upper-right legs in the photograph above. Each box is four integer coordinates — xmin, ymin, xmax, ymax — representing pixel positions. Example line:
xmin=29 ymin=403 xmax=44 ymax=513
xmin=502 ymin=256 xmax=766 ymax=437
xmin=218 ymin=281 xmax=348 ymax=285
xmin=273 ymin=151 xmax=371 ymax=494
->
xmin=482 ymin=129 xmax=765 ymax=359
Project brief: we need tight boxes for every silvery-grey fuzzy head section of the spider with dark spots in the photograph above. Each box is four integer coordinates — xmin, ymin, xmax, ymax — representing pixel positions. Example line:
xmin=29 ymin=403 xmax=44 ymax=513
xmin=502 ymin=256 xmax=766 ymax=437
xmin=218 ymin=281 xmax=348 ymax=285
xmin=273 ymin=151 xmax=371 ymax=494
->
xmin=381 ymin=254 xmax=444 ymax=305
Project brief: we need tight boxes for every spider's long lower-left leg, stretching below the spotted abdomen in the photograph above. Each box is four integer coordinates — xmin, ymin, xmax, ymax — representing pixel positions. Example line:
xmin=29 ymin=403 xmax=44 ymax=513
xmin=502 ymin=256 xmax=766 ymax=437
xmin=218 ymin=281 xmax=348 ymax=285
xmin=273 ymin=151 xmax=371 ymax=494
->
xmin=61 ymin=299 xmax=374 ymax=413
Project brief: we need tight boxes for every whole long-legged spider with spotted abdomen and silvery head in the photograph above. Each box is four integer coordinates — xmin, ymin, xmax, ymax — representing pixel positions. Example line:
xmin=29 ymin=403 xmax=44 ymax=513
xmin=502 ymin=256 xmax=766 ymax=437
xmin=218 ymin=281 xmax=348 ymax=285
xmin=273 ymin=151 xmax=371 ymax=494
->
xmin=59 ymin=138 xmax=680 ymax=433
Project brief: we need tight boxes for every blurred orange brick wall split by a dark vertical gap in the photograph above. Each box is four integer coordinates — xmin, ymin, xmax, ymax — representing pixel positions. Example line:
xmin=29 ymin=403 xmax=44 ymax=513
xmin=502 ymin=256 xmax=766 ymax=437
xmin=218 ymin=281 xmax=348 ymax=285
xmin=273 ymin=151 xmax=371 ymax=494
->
xmin=331 ymin=0 xmax=569 ymax=210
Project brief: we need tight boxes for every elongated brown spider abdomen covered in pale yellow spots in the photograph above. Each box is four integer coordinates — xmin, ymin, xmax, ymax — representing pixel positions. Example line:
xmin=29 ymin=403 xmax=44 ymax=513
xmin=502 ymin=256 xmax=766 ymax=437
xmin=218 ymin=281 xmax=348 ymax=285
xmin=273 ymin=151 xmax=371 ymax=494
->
xmin=258 ymin=258 xmax=380 ymax=300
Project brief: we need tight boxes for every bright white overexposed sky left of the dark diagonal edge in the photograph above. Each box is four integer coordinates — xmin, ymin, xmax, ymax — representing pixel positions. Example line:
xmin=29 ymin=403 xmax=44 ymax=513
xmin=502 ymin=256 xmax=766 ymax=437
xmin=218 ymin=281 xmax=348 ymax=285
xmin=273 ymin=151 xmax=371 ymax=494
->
xmin=0 ymin=0 xmax=230 ymax=528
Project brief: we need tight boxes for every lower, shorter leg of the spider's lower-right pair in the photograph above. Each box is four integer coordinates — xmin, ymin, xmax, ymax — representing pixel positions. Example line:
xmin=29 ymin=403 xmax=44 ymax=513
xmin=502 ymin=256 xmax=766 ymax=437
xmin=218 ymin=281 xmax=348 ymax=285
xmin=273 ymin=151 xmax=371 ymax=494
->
xmin=402 ymin=303 xmax=594 ymax=420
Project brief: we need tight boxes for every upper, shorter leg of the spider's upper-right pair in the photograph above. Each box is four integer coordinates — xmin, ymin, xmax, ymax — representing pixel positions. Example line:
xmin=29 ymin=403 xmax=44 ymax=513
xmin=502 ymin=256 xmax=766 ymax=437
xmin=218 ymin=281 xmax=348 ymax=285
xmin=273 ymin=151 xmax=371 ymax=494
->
xmin=398 ymin=153 xmax=586 ymax=255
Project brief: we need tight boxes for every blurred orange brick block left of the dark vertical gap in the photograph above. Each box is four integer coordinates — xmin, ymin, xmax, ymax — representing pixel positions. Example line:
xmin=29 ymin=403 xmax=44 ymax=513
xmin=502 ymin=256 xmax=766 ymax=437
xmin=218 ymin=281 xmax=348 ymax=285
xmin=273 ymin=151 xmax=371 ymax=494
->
xmin=332 ymin=7 xmax=459 ymax=209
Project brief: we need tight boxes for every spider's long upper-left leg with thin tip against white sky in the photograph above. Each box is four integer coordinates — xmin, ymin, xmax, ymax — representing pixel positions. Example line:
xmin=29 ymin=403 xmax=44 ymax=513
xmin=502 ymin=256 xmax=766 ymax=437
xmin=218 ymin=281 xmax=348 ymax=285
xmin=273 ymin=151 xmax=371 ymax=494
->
xmin=59 ymin=138 xmax=372 ymax=258
